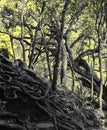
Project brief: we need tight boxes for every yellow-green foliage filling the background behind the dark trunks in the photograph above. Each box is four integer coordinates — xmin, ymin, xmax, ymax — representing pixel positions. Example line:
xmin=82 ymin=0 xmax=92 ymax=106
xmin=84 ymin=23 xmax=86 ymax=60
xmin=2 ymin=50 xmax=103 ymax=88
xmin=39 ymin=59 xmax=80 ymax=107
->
xmin=0 ymin=0 xmax=107 ymax=96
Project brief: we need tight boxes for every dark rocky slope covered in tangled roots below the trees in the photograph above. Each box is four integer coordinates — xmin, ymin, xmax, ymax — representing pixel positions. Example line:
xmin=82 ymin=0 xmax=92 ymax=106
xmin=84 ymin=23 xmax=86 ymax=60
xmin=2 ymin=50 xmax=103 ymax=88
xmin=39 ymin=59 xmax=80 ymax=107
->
xmin=0 ymin=55 xmax=100 ymax=130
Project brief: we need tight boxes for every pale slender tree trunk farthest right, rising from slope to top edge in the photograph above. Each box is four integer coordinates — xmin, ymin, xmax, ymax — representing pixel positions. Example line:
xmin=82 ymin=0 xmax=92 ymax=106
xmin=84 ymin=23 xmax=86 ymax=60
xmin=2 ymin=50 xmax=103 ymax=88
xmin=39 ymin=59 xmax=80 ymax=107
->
xmin=96 ymin=0 xmax=104 ymax=111
